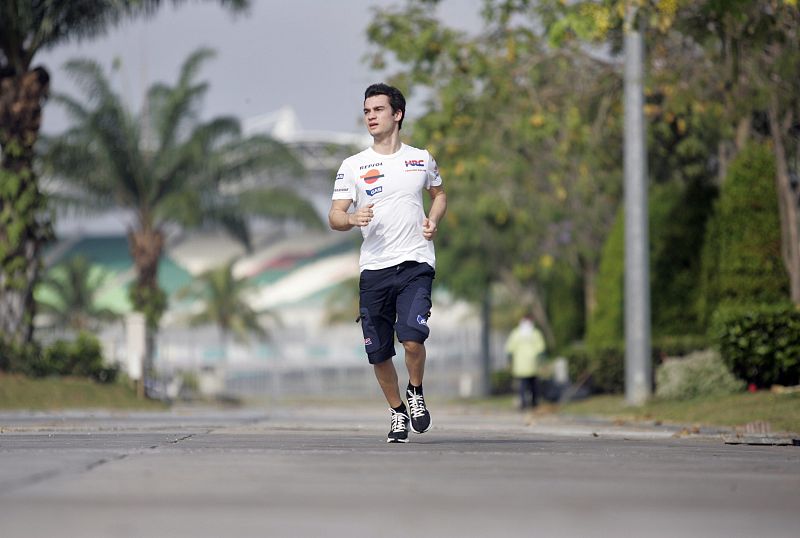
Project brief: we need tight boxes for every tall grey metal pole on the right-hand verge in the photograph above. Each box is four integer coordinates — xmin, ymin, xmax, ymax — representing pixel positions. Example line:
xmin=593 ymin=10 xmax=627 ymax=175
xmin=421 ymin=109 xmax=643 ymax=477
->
xmin=624 ymin=0 xmax=653 ymax=405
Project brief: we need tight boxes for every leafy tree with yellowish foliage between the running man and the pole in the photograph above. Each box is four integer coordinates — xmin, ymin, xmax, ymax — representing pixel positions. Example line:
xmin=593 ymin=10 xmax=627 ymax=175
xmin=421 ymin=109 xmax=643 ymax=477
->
xmin=369 ymin=1 xmax=621 ymax=344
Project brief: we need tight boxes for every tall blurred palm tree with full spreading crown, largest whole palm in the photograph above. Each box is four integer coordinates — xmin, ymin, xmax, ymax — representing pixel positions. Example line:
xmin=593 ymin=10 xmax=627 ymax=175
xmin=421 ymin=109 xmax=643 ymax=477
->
xmin=45 ymin=49 xmax=321 ymax=376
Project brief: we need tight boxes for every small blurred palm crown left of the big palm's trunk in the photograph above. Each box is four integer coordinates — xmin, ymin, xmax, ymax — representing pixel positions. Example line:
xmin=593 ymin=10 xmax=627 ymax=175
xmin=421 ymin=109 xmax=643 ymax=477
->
xmin=37 ymin=256 xmax=120 ymax=332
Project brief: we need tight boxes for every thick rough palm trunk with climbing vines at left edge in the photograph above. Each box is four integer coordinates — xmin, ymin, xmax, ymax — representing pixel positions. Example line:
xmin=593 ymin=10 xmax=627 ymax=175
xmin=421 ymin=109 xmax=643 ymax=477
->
xmin=0 ymin=67 xmax=52 ymax=345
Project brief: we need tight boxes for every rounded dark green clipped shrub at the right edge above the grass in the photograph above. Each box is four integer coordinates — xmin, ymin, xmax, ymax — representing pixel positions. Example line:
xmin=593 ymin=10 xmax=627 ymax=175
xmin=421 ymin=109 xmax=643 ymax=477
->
xmin=712 ymin=306 xmax=800 ymax=388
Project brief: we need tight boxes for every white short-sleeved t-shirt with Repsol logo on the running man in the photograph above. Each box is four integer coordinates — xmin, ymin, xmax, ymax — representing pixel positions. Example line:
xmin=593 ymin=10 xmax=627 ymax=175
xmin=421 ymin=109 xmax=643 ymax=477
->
xmin=333 ymin=144 xmax=442 ymax=271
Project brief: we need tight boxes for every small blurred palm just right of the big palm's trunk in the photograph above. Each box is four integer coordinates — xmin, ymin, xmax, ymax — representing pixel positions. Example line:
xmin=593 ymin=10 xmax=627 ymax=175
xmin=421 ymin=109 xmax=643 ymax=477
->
xmin=178 ymin=259 xmax=277 ymax=358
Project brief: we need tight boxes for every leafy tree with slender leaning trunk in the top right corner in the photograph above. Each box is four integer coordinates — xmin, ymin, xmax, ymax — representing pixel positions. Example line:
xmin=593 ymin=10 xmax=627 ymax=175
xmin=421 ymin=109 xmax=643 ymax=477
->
xmin=674 ymin=0 xmax=800 ymax=304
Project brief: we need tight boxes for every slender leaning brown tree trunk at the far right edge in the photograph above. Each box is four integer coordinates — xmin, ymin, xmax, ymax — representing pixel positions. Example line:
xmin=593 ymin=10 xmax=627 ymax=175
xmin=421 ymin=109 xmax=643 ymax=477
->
xmin=769 ymin=98 xmax=800 ymax=305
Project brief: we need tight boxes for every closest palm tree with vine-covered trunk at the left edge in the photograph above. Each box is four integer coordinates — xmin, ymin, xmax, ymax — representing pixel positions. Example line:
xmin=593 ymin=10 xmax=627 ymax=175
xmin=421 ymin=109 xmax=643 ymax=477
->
xmin=0 ymin=0 xmax=249 ymax=345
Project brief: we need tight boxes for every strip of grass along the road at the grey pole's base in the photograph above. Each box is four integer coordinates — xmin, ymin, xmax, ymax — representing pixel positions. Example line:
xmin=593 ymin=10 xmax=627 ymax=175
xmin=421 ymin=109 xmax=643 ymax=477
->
xmin=558 ymin=391 xmax=800 ymax=433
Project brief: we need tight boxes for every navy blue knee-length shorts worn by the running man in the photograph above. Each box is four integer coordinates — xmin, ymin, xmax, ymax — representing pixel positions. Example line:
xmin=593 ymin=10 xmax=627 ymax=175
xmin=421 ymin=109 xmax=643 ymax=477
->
xmin=358 ymin=262 xmax=435 ymax=364
